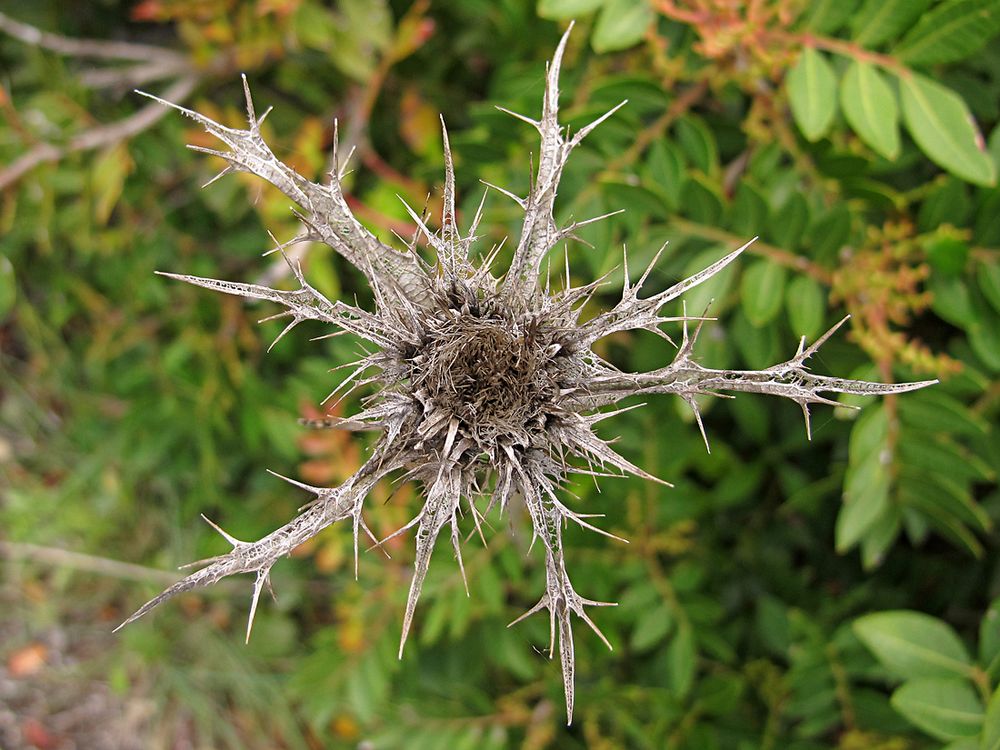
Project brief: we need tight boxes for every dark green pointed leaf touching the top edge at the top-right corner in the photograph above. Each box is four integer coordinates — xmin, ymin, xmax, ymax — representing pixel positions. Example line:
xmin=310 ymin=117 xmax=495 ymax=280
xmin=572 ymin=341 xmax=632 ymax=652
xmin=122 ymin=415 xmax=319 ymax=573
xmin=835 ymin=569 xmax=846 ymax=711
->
xmin=893 ymin=0 xmax=1000 ymax=65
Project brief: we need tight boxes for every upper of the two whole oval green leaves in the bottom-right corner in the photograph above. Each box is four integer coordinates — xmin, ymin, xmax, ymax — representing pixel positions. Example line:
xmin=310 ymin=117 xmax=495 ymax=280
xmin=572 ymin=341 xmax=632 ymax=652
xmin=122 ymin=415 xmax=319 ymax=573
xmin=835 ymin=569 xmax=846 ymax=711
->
xmin=853 ymin=610 xmax=972 ymax=679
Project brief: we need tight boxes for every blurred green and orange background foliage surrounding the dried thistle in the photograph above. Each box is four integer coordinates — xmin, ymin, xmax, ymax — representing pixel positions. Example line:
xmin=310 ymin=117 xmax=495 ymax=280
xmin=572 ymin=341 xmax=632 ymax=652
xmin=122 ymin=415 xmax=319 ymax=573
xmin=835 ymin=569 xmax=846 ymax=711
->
xmin=0 ymin=0 xmax=1000 ymax=750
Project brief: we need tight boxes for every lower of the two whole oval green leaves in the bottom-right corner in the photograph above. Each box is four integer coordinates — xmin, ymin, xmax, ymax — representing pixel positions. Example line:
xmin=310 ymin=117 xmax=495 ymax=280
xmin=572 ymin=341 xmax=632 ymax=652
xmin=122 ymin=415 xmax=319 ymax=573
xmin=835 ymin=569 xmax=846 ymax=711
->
xmin=892 ymin=679 xmax=983 ymax=742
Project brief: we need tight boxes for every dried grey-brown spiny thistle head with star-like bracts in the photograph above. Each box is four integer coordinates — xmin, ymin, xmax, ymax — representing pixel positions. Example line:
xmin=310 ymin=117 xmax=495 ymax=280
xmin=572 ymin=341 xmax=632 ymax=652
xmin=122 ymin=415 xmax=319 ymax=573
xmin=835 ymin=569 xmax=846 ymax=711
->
xmin=119 ymin=31 xmax=936 ymax=721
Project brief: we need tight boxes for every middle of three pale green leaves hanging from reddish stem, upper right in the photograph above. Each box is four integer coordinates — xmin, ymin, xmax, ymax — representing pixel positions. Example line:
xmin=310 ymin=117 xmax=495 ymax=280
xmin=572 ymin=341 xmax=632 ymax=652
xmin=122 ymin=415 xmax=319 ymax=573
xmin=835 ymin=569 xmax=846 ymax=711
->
xmin=840 ymin=61 xmax=899 ymax=160
